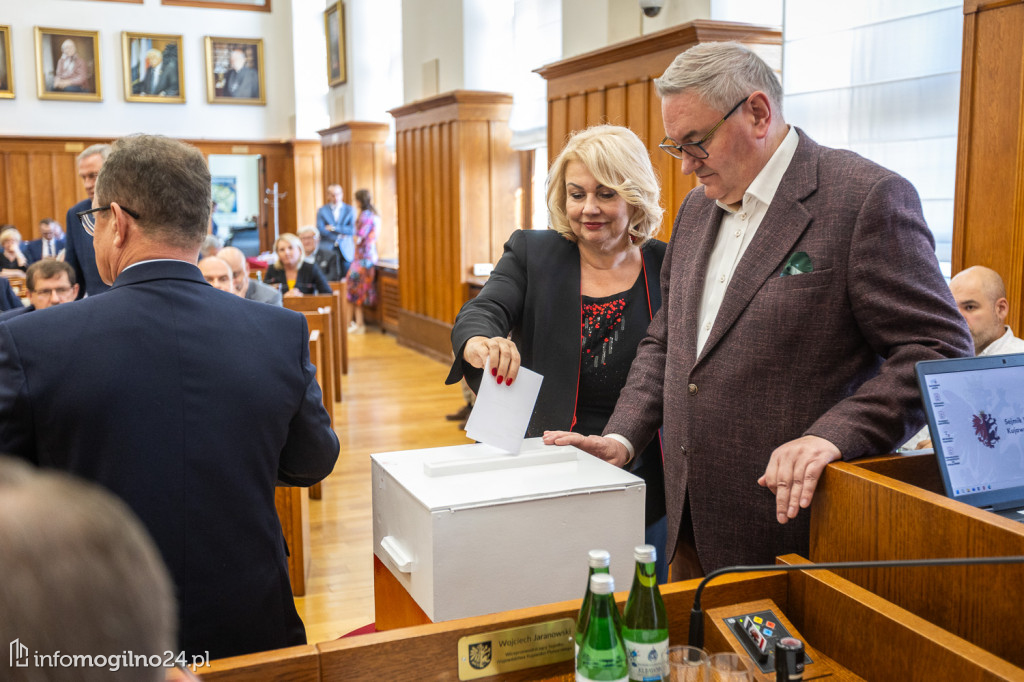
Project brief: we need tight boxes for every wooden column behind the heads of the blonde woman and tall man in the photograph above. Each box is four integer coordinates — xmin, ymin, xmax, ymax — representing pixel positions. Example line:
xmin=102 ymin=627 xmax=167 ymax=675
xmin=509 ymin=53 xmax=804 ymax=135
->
xmin=537 ymin=19 xmax=782 ymax=240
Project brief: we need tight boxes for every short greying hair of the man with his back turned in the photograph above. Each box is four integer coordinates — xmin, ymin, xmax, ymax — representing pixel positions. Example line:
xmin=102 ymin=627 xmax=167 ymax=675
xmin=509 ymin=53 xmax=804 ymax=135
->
xmin=96 ymin=135 xmax=211 ymax=250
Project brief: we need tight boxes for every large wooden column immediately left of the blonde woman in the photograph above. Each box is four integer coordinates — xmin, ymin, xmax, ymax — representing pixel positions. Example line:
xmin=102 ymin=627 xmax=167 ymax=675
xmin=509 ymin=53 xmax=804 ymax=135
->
xmin=390 ymin=90 xmax=520 ymax=361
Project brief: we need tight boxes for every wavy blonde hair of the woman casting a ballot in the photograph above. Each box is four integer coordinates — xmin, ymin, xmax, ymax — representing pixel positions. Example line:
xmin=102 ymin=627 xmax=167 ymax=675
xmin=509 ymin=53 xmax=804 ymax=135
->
xmin=547 ymin=125 xmax=665 ymax=246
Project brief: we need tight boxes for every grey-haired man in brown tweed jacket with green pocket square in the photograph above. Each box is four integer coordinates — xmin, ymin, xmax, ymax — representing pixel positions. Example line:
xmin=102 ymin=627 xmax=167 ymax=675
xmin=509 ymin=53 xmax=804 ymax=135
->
xmin=546 ymin=43 xmax=972 ymax=580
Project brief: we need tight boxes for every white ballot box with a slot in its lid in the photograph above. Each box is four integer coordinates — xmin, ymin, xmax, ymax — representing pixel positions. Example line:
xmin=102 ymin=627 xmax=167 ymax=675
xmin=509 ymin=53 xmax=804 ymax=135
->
xmin=371 ymin=438 xmax=645 ymax=623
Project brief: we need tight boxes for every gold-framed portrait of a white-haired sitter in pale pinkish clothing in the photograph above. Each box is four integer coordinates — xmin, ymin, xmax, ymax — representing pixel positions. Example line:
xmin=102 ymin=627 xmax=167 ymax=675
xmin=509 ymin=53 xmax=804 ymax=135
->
xmin=35 ymin=26 xmax=103 ymax=101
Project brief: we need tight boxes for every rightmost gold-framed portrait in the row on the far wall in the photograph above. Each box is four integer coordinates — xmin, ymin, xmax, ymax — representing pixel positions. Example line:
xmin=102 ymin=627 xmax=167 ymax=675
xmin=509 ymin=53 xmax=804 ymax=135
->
xmin=205 ymin=36 xmax=266 ymax=104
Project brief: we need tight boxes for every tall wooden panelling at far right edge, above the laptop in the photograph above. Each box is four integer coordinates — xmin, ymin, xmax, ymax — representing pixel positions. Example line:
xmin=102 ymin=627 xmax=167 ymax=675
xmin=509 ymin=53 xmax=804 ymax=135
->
xmin=952 ymin=0 xmax=1024 ymax=334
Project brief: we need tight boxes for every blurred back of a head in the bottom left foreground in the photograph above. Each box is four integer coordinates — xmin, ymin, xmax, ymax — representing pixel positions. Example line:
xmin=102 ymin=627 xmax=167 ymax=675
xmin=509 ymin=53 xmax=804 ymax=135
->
xmin=0 ymin=457 xmax=177 ymax=682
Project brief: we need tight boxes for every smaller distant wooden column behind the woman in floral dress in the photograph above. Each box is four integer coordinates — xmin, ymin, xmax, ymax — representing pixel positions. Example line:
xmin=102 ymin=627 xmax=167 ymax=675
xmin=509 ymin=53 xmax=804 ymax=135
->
xmin=316 ymin=121 xmax=398 ymax=258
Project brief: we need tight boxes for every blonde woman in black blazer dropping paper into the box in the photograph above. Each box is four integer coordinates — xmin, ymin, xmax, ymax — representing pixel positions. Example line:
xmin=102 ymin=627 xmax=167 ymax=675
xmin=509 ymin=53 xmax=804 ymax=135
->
xmin=447 ymin=125 xmax=668 ymax=581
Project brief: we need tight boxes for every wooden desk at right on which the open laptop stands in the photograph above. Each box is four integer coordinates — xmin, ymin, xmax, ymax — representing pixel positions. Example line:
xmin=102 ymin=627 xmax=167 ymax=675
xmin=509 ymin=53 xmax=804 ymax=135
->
xmin=810 ymin=455 xmax=1024 ymax=666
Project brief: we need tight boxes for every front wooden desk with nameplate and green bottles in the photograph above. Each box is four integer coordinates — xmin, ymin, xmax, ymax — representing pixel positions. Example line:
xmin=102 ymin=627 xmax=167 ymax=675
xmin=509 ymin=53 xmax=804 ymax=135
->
xmin=193 ymin=555 xmax=1024 ymax=682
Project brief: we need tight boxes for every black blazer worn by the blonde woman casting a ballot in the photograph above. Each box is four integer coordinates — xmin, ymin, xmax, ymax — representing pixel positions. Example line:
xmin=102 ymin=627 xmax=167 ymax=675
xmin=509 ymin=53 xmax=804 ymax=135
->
xmin=445 ymin=229 xmax=666 ymax=523
